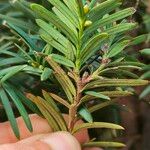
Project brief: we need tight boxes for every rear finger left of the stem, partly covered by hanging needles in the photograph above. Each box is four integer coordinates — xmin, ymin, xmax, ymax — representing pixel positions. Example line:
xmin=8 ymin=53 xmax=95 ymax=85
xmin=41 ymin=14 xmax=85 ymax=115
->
xmin=0 ymin=114 xmax=52 ymax=144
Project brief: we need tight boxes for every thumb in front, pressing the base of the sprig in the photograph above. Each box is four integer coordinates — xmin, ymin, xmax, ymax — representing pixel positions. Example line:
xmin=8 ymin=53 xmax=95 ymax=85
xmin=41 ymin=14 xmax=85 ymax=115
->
xmin=0 ymin=132 xmax=81 ymax=150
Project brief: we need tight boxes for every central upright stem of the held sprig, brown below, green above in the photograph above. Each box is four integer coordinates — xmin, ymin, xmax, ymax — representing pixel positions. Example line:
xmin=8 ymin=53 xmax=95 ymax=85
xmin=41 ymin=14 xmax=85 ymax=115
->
xmin=68 ymin=0 xmax=85 ymax=132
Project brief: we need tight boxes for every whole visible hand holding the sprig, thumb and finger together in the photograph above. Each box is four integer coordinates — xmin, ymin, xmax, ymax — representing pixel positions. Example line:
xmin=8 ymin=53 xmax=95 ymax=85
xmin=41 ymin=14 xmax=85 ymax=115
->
xmin=0 ymin=115 xmax=102 ymax=150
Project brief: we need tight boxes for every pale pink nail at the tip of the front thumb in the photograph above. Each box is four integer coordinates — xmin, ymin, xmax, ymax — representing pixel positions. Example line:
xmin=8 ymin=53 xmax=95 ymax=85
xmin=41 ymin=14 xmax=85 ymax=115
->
xmin=40 ymin=132 xmax=81 ymax=150
